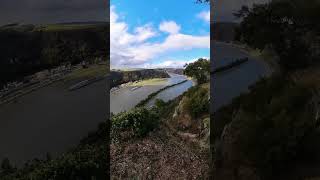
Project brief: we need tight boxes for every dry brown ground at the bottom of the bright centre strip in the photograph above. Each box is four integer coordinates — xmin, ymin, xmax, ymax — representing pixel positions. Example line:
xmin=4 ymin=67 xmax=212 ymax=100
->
xmin=111 ymin=127 xmax=209 ymax=179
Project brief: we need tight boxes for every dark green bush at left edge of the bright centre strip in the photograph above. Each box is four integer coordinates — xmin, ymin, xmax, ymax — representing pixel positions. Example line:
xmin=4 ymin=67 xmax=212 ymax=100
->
xmin=111 ymin=108 xmax=159 ymax=140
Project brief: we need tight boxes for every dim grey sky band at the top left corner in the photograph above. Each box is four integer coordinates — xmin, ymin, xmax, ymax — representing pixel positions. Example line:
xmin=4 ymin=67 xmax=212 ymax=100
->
xmin=0 ymin=0 xmax=109 ymax=25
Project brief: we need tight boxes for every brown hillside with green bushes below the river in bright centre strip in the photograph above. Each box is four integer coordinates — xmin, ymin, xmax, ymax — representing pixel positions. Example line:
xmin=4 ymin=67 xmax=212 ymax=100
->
xmin=110 ymin=83 xmax=210 ymax=179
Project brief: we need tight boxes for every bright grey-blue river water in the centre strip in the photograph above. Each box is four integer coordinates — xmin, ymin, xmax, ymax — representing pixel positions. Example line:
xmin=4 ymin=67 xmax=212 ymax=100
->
xmin=110 ymin=73 xmax=194 ymax=114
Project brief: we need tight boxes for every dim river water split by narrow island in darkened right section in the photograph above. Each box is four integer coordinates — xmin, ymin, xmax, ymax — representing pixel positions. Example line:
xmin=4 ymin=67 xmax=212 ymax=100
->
xmin=210 ymin=42 xmax=270 ymax=112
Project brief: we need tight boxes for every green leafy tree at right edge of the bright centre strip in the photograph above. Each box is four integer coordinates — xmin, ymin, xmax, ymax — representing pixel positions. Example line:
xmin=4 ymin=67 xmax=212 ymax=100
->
xmin=184 ymin=58 xmax=210 ymax=84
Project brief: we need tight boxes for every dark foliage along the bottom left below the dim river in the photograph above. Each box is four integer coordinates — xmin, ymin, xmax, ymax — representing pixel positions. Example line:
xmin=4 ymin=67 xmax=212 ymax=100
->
xmin=0 ymin=123 xmax=109 ymax=180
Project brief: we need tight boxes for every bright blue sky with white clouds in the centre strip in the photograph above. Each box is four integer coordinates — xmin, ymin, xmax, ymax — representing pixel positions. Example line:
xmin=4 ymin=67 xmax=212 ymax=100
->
xmin=110 ymin=0 xmax=210 ymax=68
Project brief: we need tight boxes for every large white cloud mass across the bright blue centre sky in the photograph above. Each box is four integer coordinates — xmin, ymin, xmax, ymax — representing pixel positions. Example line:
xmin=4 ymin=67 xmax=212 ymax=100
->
xmin=110 ymin=6 xmax=210 ymax=67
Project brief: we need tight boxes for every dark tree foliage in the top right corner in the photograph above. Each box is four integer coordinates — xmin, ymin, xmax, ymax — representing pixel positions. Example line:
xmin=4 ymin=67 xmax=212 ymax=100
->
xmin=235 ymin=0 xmax=320 ymax=71
